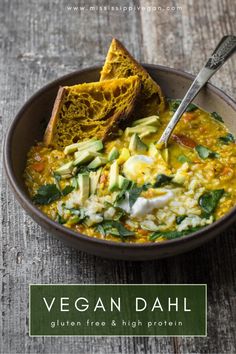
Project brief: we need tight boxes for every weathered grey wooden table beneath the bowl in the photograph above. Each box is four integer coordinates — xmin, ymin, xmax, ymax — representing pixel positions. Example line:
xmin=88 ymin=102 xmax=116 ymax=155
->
xmin=0 ymin=0 xmax=236 ymax=353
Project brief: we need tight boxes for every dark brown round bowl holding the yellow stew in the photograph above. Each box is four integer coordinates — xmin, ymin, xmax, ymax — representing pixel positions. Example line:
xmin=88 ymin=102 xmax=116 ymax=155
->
xmin=4 ymin=65 xmax=236 ymax=261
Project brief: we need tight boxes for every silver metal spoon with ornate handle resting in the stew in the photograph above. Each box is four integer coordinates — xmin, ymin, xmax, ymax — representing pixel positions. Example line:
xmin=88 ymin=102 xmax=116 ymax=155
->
xmin=158 ymin=35 xmax=236 ymax=147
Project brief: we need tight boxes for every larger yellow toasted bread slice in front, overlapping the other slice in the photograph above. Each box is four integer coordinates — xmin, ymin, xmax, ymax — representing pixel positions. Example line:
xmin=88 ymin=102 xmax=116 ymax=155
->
xmin=44 ymin=76 xmax=141 ymax=149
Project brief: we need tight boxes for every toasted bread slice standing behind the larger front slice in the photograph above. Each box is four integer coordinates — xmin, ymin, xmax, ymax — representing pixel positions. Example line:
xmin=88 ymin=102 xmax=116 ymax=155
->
xmin=100 ymin=38 xmax=165 ymax=117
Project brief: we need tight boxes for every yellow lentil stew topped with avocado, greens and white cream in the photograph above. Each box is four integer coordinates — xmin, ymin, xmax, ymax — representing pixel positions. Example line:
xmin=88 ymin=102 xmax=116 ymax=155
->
xmin=24 ymin=100 xmax=236 ymax=243
